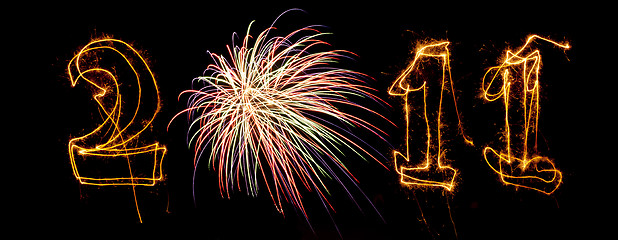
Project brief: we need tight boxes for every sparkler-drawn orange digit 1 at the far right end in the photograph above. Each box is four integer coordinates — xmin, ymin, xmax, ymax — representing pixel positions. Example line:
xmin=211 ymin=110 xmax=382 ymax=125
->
xmin=483 ymin=35 xmax=570 ymax=195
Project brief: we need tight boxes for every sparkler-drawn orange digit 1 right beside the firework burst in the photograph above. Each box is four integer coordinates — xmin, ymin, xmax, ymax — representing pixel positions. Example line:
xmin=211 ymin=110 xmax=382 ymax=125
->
xmin=388 ymin=41 xmax=472 ymax=191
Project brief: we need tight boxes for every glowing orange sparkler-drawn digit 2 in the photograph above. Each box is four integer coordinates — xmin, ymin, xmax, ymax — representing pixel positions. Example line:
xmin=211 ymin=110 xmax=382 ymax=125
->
xmin=67 ymin=38 xmax=166 ymax=222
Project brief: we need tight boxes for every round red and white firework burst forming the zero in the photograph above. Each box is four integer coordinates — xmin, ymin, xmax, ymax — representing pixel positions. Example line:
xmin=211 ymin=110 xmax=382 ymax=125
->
xmin=174 ymin=13 xmax=388 ymax=224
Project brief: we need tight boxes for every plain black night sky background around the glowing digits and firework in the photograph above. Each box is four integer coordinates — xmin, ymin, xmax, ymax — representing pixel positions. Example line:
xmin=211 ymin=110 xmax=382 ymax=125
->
xmin=14 ymin=1 xmax=613 ymax=239
